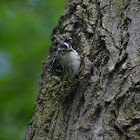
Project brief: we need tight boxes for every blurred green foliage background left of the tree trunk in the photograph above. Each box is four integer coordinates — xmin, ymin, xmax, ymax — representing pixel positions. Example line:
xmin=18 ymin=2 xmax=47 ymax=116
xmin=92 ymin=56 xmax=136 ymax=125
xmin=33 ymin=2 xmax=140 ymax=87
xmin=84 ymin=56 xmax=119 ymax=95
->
xmin=0 ymin=0 xmax=66 ymax=140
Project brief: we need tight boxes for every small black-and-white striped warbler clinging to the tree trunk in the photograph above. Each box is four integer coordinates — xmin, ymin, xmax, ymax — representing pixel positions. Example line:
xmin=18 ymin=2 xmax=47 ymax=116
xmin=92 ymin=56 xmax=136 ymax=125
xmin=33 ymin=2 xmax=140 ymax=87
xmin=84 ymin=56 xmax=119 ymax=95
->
xmin=48 ymin=43 xmax=81 ymax=81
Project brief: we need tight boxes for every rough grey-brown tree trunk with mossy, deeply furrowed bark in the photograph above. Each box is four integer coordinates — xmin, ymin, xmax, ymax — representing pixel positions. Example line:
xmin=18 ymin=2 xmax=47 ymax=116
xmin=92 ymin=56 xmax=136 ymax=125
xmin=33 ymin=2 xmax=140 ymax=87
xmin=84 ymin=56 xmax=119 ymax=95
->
xmin=25 ymin=0 xmax=140 ymax=140
